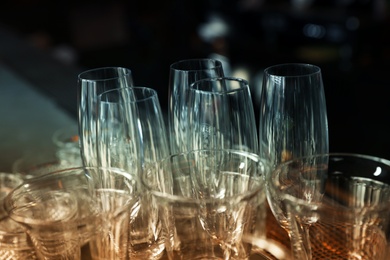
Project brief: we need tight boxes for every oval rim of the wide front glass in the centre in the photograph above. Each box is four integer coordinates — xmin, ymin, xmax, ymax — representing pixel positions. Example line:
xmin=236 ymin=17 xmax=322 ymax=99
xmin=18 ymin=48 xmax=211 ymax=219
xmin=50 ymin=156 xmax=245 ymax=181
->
xmin=140 ymin=149 xmax=270 ymax=204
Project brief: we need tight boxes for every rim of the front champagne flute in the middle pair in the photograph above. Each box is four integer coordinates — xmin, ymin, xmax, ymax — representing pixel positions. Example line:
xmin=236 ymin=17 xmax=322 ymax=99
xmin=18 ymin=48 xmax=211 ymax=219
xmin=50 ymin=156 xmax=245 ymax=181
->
xmin=190 ymin=76 xmax=250 ymax=94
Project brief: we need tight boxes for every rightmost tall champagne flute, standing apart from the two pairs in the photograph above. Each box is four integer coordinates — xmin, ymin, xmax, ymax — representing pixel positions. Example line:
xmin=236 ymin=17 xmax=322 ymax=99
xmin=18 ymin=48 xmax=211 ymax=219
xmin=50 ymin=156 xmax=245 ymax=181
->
xmin=259 ymin=63 xmax=329 ymax=232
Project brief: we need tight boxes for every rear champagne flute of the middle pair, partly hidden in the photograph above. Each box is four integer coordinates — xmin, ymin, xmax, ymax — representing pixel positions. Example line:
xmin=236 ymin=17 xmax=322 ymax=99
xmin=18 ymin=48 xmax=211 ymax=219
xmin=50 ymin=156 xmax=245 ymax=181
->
xmin=168 ymin=59 xmax=224 ymax=153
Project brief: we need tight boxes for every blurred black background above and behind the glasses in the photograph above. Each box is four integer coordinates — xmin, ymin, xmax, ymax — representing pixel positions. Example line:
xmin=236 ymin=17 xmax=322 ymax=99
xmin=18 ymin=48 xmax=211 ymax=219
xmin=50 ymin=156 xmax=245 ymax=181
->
xmin=0 ymin=0 xmax=390 ymax=159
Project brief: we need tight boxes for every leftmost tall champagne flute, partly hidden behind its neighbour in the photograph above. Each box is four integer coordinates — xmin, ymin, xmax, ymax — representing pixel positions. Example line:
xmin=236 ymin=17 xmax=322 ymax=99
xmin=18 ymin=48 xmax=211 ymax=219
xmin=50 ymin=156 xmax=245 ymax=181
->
xmin=77 ymin=67 xmax=133 ymax=166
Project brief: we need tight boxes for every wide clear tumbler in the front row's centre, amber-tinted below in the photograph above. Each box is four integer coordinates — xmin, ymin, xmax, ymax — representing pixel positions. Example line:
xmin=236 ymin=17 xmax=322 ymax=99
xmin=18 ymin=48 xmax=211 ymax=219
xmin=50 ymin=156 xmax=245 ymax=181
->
xmin=141 ymin=150 xmax=267 ymax=260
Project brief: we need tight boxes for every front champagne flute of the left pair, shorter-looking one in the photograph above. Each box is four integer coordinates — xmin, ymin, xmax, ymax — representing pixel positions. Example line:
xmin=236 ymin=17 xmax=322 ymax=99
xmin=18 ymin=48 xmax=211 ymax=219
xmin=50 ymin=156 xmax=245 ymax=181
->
xmin=96 ymin=88 xmax=140 ymax=175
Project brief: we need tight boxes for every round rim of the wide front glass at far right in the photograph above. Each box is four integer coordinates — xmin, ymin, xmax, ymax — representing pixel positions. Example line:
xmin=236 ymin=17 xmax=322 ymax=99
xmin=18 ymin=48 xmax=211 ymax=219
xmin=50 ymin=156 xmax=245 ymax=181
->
xmin=269 ymin=153 xmax=390 ymax=212
